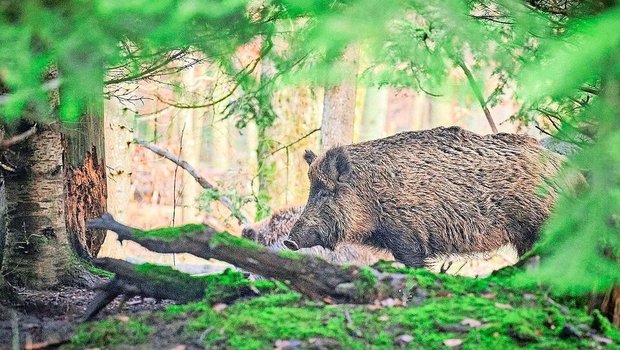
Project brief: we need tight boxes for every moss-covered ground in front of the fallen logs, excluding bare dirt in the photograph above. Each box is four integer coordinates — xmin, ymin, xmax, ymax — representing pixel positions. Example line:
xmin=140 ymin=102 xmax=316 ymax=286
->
xmin=72 ymin=264 xmax=620 ymax=349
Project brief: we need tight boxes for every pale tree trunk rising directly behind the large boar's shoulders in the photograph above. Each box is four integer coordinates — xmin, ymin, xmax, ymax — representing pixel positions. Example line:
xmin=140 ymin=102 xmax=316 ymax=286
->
xmin=321 ymin=45 xmax=359 ymax=151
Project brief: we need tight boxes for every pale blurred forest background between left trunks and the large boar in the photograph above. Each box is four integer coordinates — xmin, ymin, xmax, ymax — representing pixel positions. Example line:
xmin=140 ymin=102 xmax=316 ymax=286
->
xmin=100 ymin=42 xmax=528 ymax=270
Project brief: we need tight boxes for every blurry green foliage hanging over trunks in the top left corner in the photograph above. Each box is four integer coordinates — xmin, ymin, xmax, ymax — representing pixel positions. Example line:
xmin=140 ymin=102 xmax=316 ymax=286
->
xmin=0 ymin=0 xmax=272 ymax=122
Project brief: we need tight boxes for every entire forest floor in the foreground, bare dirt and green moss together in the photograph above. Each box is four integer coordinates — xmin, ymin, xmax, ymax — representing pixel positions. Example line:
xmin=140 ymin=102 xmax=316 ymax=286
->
xmin=0 ymin=263 xmax=620 ymax=349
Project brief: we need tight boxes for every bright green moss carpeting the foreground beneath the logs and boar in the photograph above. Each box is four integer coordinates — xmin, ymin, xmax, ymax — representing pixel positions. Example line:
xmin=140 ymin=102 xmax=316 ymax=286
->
xmin=74 ymin=267 xmax=620 ymax=349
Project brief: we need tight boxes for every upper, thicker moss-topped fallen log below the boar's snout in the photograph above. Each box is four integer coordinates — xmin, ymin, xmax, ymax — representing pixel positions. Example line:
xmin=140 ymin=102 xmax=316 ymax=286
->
xmin=87 ymin=214 xmax=408 ymax=304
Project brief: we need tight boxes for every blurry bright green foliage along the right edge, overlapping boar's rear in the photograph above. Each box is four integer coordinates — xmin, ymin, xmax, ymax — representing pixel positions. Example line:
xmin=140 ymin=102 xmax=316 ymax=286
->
xmin=522 ymin=7 xmax=620 ymax=294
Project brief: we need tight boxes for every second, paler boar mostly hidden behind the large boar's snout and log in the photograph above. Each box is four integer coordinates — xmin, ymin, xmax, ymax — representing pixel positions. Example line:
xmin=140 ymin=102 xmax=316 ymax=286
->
xmin=242 ymin=207 xmax=394 ymax=265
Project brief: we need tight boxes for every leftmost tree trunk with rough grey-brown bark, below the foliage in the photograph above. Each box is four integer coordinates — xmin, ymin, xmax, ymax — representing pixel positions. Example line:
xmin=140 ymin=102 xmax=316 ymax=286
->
xmin=3 ymin=125 xmax=71 ymax=288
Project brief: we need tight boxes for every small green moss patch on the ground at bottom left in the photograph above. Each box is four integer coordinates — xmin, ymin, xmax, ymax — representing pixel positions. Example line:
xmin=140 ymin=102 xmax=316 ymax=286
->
xmin=70 ymin=319 xmax=152 ymax=349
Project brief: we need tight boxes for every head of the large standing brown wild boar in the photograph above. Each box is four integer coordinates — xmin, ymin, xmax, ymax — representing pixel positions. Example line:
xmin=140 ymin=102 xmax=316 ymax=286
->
xmin=284 ymin=147 xmax=370 ymax=250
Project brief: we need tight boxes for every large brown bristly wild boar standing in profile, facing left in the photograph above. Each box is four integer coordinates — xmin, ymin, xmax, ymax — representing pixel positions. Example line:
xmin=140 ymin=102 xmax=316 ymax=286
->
xmin=285 ymin=127 xmax=563 ymax=267
